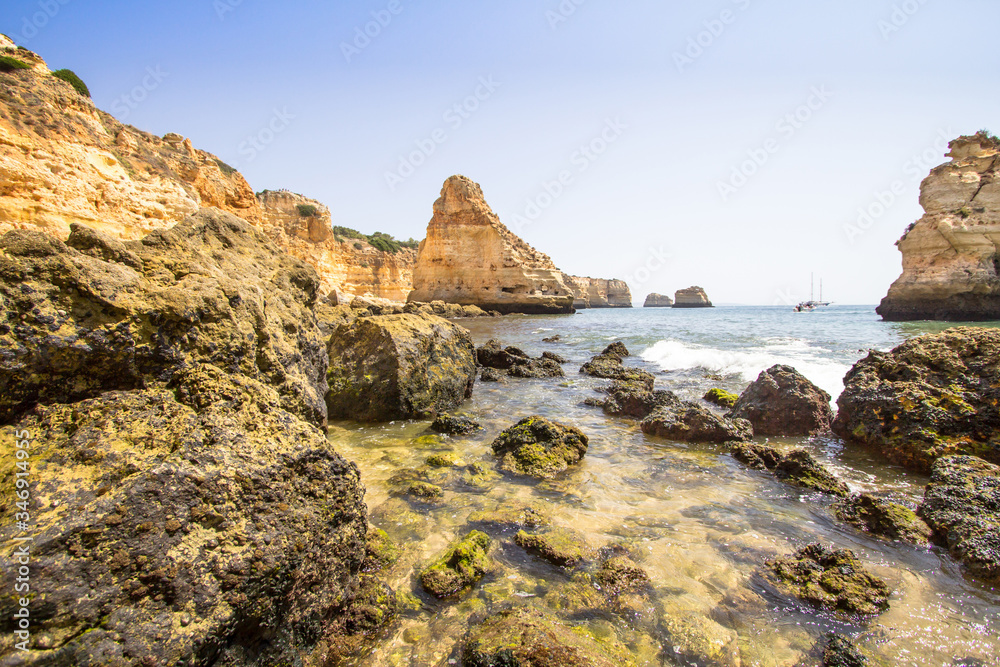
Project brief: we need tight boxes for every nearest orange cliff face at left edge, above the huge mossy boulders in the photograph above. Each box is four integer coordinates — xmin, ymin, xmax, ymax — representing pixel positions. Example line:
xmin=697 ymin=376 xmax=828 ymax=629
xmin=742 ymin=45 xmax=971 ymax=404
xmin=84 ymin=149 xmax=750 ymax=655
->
xmin=0 ymin=40 xmax=261 ymax=240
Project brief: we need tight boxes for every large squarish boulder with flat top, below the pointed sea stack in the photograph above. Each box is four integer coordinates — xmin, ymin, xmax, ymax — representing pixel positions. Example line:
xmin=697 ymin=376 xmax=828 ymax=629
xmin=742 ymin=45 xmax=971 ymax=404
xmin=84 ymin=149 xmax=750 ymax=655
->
xmin=326 ymin=314 xmax=476 ymax=422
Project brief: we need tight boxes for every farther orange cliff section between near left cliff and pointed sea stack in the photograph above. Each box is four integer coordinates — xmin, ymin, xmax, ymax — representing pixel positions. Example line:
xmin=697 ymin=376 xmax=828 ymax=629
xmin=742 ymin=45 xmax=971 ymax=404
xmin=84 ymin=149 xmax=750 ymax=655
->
xmin=258 ymin=190 xmax=417 ymax=301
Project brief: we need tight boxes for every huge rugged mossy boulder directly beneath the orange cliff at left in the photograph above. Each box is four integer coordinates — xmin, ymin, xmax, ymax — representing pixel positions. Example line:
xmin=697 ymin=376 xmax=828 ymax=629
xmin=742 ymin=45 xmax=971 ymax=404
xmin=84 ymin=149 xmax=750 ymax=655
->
xmin=0 ymin=209 xmax=328 ymax=424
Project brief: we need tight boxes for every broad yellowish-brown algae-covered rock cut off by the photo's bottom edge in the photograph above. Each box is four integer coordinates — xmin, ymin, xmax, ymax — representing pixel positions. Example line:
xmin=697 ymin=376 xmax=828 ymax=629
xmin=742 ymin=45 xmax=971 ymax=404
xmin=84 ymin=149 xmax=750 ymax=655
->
xmin=462 ymin=607 xmax=635 ymax=667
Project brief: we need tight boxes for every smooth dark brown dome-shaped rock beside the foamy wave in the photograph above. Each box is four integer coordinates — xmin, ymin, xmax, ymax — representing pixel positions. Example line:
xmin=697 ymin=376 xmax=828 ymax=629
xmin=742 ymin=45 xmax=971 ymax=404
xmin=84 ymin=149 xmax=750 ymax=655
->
xmin=730 ymin=365 xmax=833 ymax=436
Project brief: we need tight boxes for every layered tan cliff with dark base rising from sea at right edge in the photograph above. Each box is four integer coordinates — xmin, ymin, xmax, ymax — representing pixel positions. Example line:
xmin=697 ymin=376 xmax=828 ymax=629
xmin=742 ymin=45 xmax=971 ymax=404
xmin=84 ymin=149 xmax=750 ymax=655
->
xmin=877 ymin=132 xmax=1000 ymax=321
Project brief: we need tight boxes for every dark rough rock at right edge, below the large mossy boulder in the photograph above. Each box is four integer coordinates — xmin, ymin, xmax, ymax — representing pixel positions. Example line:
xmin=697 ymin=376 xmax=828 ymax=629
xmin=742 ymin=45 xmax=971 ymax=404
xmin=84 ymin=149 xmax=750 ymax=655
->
xmin=918 ymin=456 xmax=1000 ymax=582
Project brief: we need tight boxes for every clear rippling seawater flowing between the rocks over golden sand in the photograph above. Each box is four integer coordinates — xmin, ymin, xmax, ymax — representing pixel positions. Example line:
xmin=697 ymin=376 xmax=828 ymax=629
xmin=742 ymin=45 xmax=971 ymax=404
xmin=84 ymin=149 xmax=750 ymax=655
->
xmin=330 ymin=308 xmax=1000 ymax=667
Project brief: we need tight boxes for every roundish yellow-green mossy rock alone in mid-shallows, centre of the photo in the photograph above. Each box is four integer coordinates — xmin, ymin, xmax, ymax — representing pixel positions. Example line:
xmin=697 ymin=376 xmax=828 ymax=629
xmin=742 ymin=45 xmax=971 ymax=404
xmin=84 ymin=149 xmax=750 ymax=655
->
xmin=492 ymin=416 xmax=588 ymax=479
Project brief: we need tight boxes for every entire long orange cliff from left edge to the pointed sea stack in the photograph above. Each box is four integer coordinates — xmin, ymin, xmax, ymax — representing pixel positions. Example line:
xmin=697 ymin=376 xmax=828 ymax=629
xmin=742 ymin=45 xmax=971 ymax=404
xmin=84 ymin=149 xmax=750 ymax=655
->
xmin=0 ymin=35 xmax=416 ymax=301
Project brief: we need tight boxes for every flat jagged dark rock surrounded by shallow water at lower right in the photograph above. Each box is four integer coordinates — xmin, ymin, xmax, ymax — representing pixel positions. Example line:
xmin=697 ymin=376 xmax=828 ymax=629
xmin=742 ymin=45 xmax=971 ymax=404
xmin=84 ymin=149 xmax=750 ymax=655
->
xmin=765 ymin=544 xmax=892 ymax=617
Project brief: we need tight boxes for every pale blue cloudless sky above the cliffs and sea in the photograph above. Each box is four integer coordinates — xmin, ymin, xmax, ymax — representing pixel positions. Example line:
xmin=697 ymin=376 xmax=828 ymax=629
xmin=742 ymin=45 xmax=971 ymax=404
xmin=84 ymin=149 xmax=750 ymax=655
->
xmin=0 ymin=0 xmax=1000 ymax=305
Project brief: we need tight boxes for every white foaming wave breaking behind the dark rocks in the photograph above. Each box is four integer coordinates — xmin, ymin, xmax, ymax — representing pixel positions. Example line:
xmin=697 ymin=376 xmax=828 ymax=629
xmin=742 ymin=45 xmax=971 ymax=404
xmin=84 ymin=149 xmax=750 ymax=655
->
xmin=640 ymin=338 xmax=851 ymax=400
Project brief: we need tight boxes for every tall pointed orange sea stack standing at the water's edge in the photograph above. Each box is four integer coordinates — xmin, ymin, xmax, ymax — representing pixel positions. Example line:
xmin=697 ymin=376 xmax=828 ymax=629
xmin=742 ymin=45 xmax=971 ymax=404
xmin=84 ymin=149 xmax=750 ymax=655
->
xmin=408 ymin=176 xmax=576 ymax=314
